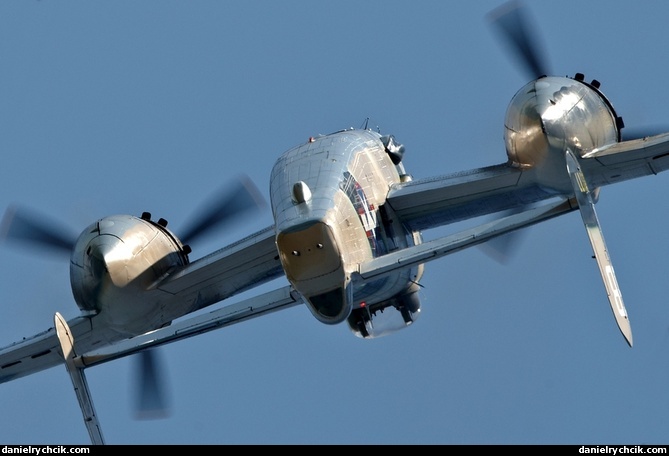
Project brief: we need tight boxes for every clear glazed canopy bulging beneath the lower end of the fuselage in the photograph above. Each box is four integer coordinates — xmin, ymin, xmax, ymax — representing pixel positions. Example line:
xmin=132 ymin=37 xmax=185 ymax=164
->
xmin=346 ymin=283 xmax=420 ymax=339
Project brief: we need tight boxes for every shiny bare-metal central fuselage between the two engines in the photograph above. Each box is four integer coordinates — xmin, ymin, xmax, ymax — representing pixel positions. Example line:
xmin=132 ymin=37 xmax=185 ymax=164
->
xmin=270 ymin=130 xmax=422 ymax=335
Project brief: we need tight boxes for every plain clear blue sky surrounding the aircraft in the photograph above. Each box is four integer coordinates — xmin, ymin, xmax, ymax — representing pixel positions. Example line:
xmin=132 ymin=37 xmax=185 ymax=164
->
xmin=0 ymin=0 xmax=669 ymax=444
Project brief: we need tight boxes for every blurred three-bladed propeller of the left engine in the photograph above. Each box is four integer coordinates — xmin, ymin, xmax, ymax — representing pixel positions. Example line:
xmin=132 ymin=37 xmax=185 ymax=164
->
xmin=0 ymin=176 xmax=264 ymax=419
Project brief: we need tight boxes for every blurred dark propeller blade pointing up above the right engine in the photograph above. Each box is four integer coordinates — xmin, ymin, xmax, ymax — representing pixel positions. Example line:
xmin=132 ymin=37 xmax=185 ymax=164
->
xmin=487 ymin=1 xmax=552 ymax=79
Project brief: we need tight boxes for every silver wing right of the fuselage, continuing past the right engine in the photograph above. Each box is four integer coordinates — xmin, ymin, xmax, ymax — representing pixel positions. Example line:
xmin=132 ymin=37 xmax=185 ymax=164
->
xmin=387 ymin=133 xmax=669 ymax=230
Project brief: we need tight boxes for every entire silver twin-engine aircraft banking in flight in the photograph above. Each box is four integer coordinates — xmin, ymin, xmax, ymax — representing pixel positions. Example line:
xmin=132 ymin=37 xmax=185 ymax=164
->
xmin=0 ymin=0 xmax=669 ymax=444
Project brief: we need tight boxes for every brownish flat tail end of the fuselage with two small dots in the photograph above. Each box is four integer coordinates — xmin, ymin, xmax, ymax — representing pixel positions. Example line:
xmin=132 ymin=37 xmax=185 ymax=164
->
xmin=277 ymin=221 xmax=351 ymax=324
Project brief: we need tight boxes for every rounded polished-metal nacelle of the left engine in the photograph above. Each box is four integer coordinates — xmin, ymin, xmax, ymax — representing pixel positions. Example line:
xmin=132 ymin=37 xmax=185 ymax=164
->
xmin=70 ymin=213 xmax=190 ymax=334
